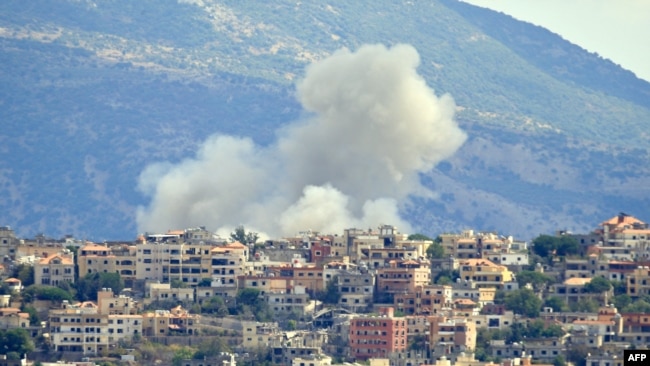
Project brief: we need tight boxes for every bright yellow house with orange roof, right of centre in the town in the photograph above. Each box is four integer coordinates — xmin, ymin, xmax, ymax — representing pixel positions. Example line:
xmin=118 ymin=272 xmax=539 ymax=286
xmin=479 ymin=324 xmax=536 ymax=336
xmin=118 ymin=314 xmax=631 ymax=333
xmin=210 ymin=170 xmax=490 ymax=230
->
xmin=459 ymin=259 xmax=514 ymax=289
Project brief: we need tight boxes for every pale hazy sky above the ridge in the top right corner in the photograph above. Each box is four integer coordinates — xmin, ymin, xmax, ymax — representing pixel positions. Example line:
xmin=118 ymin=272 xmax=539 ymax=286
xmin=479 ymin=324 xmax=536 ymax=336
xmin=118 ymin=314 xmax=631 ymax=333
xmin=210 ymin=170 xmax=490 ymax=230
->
xmin=463 ymin=0 xmax=650 ymax=81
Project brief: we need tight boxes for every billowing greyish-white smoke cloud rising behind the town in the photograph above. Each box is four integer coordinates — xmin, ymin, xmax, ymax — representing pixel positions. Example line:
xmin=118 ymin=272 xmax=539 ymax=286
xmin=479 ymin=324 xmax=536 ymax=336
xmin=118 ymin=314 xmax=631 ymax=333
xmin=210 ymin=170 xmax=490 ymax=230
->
xmin=137 ymin=45 xmax=466 ymax=236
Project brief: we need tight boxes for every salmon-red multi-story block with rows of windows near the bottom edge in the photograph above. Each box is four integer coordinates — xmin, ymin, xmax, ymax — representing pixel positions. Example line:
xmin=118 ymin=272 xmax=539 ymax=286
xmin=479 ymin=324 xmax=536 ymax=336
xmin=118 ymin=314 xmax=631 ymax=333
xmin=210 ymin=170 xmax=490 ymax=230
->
xmin=350 ymin=307 xmax=408 ymax=361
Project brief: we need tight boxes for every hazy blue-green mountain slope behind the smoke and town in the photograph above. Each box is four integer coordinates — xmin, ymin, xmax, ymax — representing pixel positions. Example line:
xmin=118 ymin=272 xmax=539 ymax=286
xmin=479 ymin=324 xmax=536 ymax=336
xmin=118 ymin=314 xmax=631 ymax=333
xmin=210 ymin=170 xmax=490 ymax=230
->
xmin=0 ymin=0 xmax=650 ymax=240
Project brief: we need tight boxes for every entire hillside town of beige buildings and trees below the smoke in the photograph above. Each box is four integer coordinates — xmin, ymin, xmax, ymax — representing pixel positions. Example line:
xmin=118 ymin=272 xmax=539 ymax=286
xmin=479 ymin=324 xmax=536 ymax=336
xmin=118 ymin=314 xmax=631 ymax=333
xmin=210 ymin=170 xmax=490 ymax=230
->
xmin=0 ymin=213 xmax=650 ymax=366
